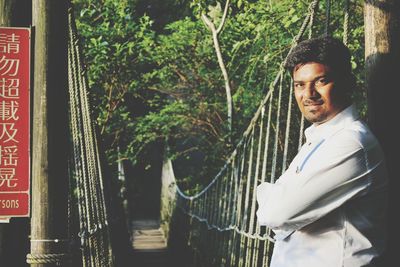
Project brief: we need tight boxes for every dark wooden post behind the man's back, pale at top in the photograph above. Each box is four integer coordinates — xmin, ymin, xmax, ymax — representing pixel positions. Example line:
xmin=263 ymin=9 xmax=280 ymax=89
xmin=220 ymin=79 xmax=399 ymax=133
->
xmin=364 ymin=0 xmax=400 ymax=266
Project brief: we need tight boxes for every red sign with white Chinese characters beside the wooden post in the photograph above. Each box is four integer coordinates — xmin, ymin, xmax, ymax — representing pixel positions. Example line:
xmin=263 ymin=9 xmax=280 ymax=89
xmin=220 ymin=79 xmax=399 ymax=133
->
xmin=0 ymin=27 xmax=31 ymax=218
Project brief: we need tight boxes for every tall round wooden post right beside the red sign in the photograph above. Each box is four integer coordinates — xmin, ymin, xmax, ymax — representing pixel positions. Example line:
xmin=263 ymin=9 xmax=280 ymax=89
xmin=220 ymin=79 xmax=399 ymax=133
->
xmin=27 ymin=0 xmax=69 ymax=267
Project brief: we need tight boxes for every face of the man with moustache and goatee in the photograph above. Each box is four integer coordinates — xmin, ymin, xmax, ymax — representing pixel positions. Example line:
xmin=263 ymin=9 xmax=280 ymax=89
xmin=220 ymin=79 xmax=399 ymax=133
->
xmin=293 ymin=62 xmax=345 ymax=124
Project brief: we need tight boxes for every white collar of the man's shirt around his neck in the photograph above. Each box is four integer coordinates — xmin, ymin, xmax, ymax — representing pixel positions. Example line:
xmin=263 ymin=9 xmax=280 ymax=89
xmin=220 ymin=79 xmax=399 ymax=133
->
xmin=304 ymin=105 xmax=359 ymax=142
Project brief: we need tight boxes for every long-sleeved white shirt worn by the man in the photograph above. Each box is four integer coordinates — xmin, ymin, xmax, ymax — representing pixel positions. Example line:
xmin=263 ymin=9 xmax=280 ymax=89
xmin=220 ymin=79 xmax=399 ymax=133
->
xmin=257 ymin=106 xmax=387 ymax=267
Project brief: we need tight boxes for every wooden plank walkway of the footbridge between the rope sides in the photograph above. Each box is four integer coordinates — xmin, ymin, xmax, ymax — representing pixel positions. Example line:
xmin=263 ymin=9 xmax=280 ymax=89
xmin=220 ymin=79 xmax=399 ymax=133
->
xmin=132 ymin=219 xmax=169 ymax=267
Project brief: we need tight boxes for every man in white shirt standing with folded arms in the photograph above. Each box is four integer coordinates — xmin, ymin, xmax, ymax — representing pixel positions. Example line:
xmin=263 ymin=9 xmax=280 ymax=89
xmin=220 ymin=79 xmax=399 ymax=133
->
xmin=257 ymin=37 xmax=387 ymax=267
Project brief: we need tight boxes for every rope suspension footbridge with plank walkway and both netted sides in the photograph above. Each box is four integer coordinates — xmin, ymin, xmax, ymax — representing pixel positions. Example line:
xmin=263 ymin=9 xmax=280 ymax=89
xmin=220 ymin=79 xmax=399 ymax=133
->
xmin=0 ymin=0 xmax=392 ymax=267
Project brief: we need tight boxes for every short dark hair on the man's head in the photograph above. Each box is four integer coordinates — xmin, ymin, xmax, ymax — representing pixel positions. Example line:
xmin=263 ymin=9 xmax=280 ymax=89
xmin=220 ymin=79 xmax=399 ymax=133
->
xmin=285 ymin=36 xmax=355 ymax=95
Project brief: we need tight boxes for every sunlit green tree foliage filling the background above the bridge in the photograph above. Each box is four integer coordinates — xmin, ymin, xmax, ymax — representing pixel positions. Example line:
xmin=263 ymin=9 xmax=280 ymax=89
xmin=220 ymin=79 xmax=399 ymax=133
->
xmin=74 ymin=0 xmax=365 ymax=191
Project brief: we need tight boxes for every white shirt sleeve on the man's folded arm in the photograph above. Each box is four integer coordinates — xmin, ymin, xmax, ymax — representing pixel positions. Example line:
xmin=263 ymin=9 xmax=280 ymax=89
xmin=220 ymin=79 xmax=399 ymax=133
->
xmin=257 ymin=132 xmax=380 ymax=231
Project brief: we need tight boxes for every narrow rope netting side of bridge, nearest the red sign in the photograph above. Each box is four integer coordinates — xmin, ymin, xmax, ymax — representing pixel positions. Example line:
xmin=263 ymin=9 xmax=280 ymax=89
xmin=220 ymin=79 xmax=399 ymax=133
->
xmin=68 ymin=8 xmax=114 ymax=267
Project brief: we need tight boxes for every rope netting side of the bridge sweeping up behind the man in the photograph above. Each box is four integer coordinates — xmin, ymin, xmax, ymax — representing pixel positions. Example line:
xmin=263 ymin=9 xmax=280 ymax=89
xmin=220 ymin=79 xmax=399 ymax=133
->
xmin=162 ymin=0 xmax=356 ymax=267
